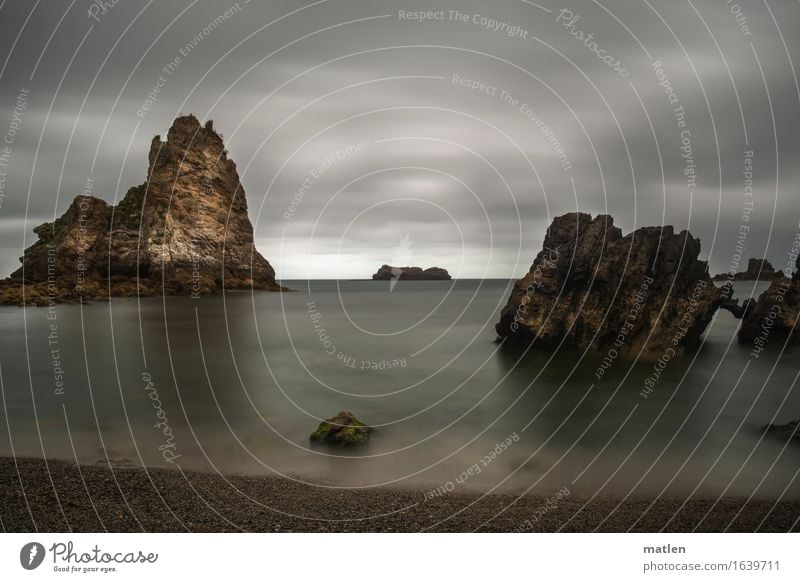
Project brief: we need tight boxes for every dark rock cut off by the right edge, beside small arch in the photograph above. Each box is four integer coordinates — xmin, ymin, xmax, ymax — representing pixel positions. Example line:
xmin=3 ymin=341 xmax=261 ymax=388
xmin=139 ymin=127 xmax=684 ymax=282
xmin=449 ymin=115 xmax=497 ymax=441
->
xmin=739 ymin=258 xmax=800 ymax=355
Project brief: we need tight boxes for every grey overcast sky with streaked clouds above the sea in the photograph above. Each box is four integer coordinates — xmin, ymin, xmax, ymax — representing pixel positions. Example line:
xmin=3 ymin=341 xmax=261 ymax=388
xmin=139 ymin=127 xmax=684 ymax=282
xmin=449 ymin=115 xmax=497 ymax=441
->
xmin=0 ymin=0 xmax=800 ymax=279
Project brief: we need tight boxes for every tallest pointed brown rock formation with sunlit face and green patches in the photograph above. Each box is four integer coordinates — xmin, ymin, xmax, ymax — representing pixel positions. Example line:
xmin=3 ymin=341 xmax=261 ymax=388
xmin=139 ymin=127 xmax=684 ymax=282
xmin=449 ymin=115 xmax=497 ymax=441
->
xmin=0 ymin=115 xmax=280 ymax=304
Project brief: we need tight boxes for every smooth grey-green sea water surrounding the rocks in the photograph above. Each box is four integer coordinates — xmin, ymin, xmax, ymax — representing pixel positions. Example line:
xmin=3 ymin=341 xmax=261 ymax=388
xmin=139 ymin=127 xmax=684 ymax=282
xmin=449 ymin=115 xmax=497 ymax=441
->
xmin=0 ymin=280 xmax=800 ymax=499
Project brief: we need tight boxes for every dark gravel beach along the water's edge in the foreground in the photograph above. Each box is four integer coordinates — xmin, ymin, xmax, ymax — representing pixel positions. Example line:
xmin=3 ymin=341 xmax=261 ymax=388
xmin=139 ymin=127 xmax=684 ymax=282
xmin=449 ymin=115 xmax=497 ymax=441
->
xmin=0 ymin=457 xmax=800 ymax=532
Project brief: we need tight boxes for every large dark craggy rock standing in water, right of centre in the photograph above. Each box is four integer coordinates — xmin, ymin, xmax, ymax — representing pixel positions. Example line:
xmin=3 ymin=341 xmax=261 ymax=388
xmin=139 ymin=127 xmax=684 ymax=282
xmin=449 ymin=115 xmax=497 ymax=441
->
xmin=496 ymin=213 xmax=723 ymax=359
